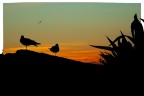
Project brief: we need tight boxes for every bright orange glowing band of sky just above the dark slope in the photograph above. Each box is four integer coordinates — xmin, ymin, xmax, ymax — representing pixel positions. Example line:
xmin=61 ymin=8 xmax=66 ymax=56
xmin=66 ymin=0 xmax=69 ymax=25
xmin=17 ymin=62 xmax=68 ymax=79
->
xmin=3 ymin=46 xmax=101 ymax=64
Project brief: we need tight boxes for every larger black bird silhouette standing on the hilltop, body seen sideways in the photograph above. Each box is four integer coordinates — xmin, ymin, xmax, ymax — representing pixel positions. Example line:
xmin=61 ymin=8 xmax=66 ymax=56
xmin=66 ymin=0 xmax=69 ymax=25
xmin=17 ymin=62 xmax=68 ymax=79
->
xmin=20 ymin=35 xmax=40 ymax=50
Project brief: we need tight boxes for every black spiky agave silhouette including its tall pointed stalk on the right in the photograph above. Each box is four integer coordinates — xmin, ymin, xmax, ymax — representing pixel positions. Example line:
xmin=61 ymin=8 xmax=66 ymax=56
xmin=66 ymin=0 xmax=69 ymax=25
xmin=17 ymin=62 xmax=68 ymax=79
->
xmin=90 ymin=14 xmax=144 ymax=65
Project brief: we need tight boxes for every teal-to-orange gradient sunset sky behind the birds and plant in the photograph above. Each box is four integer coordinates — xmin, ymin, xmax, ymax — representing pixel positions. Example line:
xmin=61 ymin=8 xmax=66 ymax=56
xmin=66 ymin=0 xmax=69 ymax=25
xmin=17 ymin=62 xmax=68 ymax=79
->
xmin=3 ymin=2 xmax=141 ymax=62
